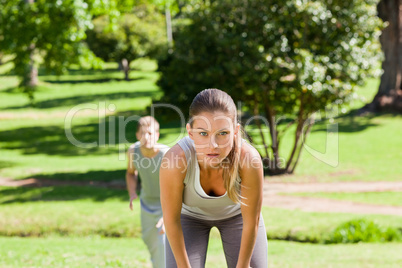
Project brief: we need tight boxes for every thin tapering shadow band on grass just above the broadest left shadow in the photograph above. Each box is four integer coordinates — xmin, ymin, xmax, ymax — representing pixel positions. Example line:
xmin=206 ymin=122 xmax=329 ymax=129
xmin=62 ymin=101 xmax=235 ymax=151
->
xmin=7 ymin=90 xmax=158 ymax=110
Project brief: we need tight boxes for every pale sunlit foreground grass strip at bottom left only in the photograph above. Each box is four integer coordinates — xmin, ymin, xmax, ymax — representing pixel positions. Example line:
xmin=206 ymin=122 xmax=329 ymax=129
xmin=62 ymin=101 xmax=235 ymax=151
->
xmin=0 ymin=236 xmax=152 ymax=268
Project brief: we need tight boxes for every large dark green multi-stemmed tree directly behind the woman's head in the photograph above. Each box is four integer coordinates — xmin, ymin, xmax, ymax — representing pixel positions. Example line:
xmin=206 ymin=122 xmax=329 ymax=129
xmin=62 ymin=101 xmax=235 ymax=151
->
xmin=158 ymin=0 xmax=381 ymax=174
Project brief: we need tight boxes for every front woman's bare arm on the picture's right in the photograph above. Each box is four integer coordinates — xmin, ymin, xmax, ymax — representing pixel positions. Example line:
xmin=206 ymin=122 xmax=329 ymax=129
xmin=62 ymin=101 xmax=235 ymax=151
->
xmin=237 ymin=143 xmax=264 ymax=268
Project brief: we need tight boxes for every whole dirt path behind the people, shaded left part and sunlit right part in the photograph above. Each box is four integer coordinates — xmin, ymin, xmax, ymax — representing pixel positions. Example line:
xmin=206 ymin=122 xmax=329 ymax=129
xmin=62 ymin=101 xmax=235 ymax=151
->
xmin=0 ymin=178 xmax=402 ymax=216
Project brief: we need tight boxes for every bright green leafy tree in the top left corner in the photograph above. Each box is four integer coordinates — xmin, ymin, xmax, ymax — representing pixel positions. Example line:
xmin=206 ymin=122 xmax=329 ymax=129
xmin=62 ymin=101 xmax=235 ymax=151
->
xmin=0 ymin=0 xmax=99 ymax=100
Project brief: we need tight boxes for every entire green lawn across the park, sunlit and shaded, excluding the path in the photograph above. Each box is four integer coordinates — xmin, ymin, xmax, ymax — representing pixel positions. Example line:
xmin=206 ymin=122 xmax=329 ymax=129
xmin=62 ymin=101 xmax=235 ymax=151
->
xmin=0 ymin=60 xmax=402 ymax=267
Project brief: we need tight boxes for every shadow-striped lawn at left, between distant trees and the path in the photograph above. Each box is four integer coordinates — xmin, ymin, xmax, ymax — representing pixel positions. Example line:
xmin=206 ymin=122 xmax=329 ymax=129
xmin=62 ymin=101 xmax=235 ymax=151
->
xmin=0 ymin=61 xmax=180 ymax=181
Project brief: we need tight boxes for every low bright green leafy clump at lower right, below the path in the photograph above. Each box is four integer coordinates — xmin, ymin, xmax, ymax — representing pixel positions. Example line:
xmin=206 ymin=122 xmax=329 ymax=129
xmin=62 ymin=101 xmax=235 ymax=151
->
xmin=325 ymin=219 xmax=402 ymax=244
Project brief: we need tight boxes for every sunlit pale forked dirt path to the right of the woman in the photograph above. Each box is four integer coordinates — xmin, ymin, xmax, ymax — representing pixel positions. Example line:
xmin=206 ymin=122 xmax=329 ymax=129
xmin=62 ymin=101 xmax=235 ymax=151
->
xmin=263 ymin=180 xmax=402 ymax=216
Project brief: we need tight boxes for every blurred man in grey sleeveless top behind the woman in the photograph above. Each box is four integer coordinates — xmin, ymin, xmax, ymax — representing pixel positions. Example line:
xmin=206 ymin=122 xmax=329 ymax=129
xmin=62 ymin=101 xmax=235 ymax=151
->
xmin=126 ymin=116 xmax=169 ymax=268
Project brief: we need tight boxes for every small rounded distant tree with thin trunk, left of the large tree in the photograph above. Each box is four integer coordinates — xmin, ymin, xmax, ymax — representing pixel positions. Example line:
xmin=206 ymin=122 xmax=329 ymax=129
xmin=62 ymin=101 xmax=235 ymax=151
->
xmin=87 ymin=5 xmax=166 ymax=80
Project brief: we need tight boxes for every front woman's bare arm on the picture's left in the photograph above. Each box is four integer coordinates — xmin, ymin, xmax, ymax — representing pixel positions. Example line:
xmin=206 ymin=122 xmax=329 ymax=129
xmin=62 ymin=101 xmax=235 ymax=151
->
xmin=159 ymin=145 xmax=190 ymax=268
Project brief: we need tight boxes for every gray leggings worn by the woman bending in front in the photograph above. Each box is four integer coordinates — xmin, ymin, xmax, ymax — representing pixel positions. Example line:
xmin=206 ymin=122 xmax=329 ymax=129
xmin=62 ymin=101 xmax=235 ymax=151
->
xmin=165 ymin=214 xmax=268 ymax=268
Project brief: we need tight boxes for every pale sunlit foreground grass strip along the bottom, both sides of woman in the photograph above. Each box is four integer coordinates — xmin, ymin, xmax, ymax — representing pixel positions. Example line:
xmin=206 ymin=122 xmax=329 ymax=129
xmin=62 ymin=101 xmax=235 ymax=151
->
xmin=0 ymin=237 xmax=402 ymax=268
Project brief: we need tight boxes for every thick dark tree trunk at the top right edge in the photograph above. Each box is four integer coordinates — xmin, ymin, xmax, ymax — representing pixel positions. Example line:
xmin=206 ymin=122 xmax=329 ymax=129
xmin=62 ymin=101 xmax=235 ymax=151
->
xmin=362 ymin=0 xmax=402 ymax=112
